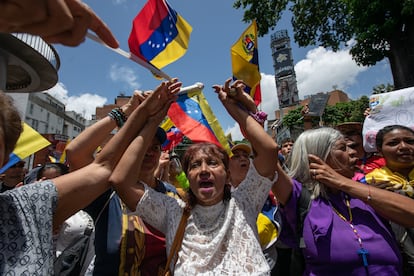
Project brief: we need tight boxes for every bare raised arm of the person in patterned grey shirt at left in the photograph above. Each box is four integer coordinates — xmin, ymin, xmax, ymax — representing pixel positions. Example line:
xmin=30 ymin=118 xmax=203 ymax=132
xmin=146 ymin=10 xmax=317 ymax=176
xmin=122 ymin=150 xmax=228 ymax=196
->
xmin=53 ymin=81 xmax=179 ymax=227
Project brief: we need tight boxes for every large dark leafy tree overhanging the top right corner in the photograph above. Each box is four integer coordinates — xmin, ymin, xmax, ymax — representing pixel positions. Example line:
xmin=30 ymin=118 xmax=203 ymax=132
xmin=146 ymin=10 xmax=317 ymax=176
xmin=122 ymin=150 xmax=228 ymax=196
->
xmin=234 ymin=0 xmax=414 ymax=89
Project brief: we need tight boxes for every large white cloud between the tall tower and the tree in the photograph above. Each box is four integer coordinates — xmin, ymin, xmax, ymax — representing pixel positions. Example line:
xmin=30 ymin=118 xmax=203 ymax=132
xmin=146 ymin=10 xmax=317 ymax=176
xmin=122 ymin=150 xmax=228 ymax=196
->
xmin=295 ymin=47 xmax=368 ymax=99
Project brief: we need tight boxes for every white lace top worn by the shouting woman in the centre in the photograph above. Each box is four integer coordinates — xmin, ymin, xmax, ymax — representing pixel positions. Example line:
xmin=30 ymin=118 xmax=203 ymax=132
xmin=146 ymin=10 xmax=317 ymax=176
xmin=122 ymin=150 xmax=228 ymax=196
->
xmin=134 ymin=162 xmax=277 ymax=275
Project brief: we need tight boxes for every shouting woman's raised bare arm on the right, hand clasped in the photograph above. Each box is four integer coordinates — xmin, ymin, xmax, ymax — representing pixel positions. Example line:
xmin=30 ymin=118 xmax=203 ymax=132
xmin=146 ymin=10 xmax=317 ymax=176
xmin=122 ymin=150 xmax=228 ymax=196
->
xmin=213 ymin=79 xmax=280 ymax=178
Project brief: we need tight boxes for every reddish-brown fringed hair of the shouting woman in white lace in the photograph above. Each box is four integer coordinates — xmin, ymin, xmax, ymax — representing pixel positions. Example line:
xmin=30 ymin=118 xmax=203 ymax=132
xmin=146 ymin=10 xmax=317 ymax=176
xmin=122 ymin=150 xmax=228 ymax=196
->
xmin=181 ymin=143 xmax=231 ymax=209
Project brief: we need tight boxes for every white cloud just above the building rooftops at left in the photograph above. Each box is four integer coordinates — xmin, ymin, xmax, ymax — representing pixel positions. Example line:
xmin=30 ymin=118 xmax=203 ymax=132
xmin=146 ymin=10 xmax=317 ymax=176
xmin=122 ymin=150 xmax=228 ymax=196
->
xmin=45 ymin=83 xmax=107 ymax=120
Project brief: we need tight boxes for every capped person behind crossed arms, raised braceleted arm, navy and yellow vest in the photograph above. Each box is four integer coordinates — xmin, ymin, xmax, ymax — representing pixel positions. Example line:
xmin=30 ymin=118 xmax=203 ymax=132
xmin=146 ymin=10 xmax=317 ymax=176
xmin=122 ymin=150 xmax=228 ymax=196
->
xmin=66 ymin=91 xmax=181 ymax=275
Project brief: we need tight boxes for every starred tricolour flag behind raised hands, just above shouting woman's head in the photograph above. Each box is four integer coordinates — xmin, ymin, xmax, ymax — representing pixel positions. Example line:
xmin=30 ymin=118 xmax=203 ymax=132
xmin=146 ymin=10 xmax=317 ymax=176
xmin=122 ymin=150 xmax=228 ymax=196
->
xmin=168 ymin=89 xmax=231 ymax=155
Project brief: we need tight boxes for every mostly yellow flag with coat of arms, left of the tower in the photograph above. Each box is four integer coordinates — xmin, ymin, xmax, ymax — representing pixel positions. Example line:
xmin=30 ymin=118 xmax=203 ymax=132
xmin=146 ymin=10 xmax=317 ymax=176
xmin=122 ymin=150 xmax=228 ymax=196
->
xmin=231 ymin=20 xmax=262 ymax=106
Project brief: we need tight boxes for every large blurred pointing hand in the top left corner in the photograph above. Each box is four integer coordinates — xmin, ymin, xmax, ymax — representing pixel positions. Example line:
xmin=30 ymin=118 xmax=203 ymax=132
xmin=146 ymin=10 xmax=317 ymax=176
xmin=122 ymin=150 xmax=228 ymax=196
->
xmin=0 ymin=0 xmax=119 ymax=48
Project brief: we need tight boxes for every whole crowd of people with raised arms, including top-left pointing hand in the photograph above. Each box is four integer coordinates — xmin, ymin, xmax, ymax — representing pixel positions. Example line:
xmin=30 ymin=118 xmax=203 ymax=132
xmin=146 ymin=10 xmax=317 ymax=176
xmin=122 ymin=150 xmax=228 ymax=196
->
xmin=0 ymin=0 xmax=414 ymax=275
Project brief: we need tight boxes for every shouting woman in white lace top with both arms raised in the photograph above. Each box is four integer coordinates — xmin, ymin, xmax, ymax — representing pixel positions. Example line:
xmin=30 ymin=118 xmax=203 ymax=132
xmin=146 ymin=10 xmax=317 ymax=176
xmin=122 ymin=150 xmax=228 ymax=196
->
xmin=110 ymin=80 xmax=281 ymax=275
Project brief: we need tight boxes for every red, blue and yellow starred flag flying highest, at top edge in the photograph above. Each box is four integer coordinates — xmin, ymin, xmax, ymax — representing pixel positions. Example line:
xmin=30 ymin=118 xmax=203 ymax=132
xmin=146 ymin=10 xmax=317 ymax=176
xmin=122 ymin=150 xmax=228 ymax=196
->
xmin=128 ymin=0 xmax=192 ymax=68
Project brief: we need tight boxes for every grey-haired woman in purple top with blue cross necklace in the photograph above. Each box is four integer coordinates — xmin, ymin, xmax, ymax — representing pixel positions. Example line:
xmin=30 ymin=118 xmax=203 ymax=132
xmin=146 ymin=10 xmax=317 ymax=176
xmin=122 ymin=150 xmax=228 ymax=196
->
xmin=273 ymin=128 xmax=414 ymax=275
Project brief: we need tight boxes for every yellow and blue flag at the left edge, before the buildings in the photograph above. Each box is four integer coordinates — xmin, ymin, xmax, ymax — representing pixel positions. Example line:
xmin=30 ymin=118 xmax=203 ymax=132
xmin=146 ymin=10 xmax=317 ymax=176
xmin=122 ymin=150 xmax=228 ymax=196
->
xmin=0 ymin=123 xmax=50 ymax=173
